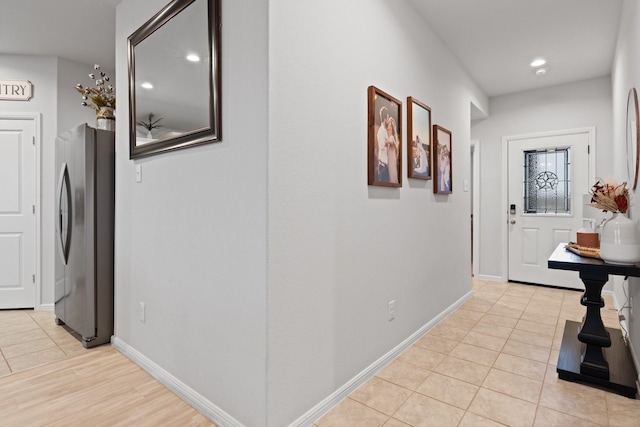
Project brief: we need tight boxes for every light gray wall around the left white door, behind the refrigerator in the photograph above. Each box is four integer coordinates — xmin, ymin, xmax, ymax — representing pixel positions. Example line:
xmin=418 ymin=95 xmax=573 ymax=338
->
xmin=0 ymin=54 xmax=92 ymax=309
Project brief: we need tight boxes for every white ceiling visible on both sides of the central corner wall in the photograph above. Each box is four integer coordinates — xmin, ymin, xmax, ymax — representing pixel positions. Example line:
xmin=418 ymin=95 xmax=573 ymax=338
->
xmin=0 ymin=0 xmax=622 ymax=96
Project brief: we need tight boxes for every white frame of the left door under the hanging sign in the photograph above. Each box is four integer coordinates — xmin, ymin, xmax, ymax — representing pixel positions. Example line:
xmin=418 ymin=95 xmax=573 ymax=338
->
xmin=0 ymin=112 xmax=42 ymax=310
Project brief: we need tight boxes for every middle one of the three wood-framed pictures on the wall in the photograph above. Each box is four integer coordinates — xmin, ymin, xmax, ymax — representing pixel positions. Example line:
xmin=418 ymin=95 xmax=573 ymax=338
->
xmin=407 ymin=96 xmax=431 ymax=179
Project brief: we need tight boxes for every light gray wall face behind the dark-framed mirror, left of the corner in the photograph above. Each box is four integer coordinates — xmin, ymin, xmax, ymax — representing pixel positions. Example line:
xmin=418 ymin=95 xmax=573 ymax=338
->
xmin=115 ymin=0 xmax=268 ymax=426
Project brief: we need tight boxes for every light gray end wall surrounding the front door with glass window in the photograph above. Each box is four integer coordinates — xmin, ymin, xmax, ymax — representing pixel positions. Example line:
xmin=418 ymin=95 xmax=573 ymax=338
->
xmin=471 ymin=77 xmax=613 ymax=277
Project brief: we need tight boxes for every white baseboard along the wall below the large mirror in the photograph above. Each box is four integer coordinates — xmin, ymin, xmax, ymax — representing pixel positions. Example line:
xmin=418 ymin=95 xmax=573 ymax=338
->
xmin=111 ymin=336 xmax=245 ymax=427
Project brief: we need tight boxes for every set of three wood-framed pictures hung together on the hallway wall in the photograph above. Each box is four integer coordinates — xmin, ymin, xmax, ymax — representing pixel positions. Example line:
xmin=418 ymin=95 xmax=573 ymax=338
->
xmin=367 ymin=86 xmax=453 ymax=194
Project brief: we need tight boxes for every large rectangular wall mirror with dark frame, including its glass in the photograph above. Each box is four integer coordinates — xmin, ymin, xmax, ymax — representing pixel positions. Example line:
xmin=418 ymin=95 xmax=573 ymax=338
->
xmin=128 ymin=0 xmax=220 ymax=159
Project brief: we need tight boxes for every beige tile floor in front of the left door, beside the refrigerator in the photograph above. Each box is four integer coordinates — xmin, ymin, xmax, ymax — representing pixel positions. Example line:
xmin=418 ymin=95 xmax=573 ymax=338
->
xmin=0 ymin=310 xmax=87 ymax=377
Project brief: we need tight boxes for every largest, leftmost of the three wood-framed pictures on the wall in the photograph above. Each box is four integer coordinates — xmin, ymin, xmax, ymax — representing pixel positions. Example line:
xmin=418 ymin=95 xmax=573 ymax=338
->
xmin=367 ymin=86 xmax=402 ymax=187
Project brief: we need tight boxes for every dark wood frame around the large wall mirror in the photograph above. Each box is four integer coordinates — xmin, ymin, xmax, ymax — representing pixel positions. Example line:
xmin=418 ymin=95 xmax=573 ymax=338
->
xmin=128 ymin=0 xmax=221 ymax=159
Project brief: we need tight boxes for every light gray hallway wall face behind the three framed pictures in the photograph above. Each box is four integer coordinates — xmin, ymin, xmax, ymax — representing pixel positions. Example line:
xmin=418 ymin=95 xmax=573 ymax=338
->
xmin=267 ymin=0 xmax=487 ymax=426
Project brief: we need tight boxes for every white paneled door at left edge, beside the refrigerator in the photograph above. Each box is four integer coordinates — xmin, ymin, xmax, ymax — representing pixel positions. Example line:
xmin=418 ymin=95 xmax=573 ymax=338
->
xmin=0 ymin=117 xmax=37 ymax=309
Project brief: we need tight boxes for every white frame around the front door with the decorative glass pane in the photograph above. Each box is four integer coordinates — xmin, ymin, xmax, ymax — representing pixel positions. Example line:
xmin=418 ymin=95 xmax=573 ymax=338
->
xmin=500 ymin=126 xmax=597 ymax=282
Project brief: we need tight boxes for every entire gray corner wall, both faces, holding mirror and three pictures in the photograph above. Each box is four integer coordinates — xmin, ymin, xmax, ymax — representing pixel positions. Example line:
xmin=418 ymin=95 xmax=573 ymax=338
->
xmin=116 ymin=0 xmax=487 ymax=426
